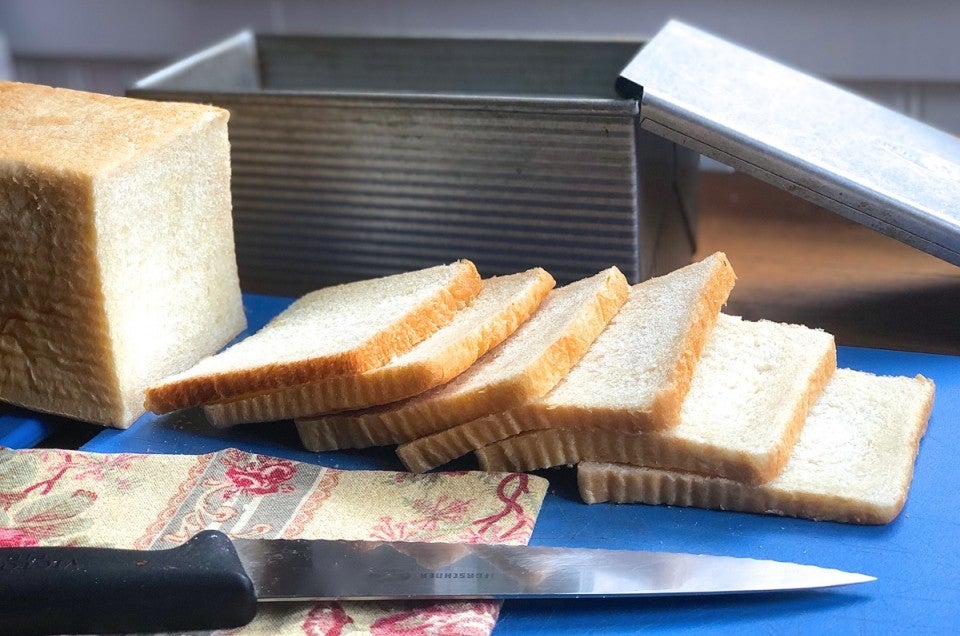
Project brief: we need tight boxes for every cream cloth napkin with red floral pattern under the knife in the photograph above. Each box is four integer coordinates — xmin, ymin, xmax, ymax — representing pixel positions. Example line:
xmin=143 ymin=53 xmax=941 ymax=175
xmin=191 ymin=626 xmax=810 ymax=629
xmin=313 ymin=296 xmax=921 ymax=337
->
xmin=0 ymin=449 xmax=547 ymax=636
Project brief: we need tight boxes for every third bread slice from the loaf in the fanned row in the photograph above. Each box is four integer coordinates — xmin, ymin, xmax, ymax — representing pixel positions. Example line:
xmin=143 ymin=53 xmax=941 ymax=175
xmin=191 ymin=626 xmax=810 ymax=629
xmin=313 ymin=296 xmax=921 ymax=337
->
xmin=296 ymin=267 xmax=629 ymax=451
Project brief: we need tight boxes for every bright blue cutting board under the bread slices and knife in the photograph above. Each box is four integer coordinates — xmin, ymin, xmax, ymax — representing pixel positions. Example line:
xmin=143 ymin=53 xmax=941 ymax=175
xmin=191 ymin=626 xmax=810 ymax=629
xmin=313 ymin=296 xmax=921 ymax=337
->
xmin=13 ymin=295 xmax=960 ymax=635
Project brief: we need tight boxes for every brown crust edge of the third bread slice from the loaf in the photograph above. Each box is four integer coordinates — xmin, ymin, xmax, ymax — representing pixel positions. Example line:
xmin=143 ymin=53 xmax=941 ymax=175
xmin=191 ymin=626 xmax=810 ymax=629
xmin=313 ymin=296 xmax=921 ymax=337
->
xmin=297 ymin=268 xmax=629 ymax=451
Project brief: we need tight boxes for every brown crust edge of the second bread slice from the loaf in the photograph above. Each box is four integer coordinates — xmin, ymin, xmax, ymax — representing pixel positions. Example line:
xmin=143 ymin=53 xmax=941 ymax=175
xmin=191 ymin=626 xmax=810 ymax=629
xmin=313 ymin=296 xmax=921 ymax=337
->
xmin=203 ymin=267 xmax=555 ymax=427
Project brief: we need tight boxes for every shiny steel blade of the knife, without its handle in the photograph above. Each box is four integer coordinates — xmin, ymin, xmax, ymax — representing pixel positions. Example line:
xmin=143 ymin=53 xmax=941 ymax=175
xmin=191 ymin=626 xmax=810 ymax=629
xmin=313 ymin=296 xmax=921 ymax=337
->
xmin=234 ymin=540 xmax=875 ymax=601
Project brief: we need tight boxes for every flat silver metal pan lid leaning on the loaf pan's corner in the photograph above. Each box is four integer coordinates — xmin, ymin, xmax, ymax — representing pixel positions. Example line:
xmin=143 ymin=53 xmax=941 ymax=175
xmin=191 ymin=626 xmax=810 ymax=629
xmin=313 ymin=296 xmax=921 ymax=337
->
xmin=617 ymin=21 xmax=960 ymax=265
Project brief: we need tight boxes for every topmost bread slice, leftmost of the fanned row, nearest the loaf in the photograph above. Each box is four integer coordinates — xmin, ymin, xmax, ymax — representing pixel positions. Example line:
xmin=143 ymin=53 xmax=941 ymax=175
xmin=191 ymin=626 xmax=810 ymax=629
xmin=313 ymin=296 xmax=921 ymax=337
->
xmin=146 ymin=260 xmax=481 ymax=413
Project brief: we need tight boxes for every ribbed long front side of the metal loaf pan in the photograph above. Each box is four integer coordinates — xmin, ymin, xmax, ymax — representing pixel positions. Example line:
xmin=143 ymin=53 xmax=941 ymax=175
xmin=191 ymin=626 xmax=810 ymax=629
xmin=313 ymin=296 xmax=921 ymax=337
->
xmin=181 ymin=95 xmax=643 ymax=294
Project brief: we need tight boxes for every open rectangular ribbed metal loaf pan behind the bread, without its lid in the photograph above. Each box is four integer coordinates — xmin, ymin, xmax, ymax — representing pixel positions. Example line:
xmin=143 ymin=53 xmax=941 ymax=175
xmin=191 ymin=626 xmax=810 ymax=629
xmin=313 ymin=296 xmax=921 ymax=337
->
xmin=129 ymin=33 xmax=697 ymax=294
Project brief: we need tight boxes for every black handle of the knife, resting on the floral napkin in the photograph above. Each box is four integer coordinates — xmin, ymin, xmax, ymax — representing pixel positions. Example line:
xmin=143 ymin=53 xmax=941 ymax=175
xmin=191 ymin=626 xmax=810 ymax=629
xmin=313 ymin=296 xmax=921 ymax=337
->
xmin=0 ymin=530 xmax=257 ymax=634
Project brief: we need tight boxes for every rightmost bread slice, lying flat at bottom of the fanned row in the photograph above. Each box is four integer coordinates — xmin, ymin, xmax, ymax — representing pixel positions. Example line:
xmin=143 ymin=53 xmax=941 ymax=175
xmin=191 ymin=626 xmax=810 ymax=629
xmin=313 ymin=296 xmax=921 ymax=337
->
xmin=577 ymin=369 xmax=934 ymax=524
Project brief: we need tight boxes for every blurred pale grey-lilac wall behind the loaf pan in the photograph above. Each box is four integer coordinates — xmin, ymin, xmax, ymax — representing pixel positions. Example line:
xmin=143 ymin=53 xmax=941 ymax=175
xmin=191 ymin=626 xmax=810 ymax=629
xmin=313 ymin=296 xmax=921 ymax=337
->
xmin=0 ymin=0 xmax=960 ymax=133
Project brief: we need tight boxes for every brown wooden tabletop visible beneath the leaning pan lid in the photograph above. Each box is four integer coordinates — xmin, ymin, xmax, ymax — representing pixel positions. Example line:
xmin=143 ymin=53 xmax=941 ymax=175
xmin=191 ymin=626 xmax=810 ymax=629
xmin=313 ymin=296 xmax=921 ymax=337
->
xmin=696 ymin=173 xmax=960 ymax=354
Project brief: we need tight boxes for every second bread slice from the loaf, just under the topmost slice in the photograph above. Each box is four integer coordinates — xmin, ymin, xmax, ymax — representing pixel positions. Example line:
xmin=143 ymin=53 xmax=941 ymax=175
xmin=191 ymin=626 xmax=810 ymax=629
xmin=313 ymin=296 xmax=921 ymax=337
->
xmin=203 ymin=267 xmax=555 ymax=426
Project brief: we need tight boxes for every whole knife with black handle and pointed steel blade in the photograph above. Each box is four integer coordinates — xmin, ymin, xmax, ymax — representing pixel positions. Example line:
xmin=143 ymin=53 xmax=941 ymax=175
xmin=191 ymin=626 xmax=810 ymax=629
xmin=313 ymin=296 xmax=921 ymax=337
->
xmin=0 ymin=530 xmax=875 ymax=634
